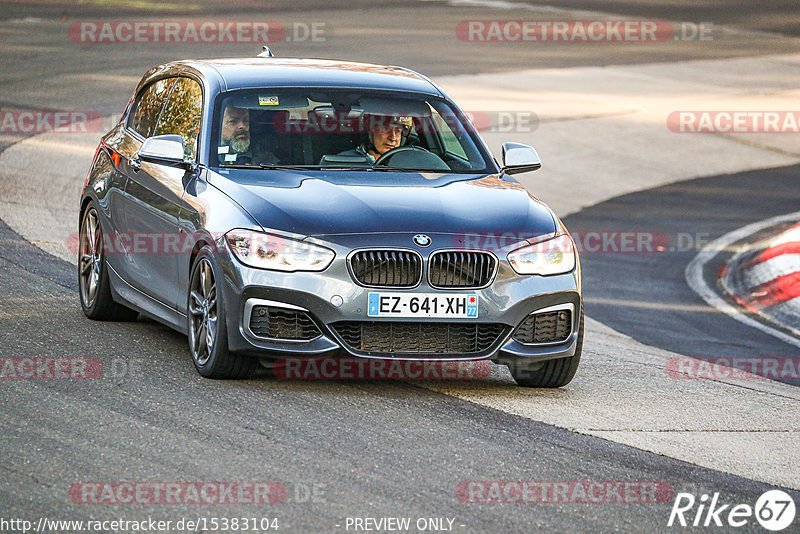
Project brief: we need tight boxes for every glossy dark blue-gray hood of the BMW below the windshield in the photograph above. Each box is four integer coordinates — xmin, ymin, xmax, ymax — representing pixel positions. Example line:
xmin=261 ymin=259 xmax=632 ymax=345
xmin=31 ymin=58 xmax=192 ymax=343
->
xmin=207 ymin=169 xmax=555 ymax=239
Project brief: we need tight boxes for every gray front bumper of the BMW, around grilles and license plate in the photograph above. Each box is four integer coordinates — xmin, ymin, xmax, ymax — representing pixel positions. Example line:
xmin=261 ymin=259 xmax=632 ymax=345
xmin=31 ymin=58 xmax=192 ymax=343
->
xmin=217 ymin=236 xmax=582 ymax=364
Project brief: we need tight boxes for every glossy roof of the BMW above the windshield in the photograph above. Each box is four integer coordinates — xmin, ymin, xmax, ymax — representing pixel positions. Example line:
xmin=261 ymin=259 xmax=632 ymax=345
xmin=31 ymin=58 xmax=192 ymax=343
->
xmin=172 ymin=57 xmax=443 ymax=96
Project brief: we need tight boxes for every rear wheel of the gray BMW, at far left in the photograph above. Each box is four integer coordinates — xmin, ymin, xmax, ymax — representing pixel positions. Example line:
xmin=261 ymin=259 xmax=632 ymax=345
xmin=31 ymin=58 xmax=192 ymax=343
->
xmin=78 ymin=203 xmax=139 ymax=321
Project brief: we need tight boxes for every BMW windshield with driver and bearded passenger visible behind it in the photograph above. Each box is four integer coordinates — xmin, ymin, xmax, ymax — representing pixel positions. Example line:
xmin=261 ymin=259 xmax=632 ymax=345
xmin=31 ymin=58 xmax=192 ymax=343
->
xmin=211 ymin=88 xmax=493 ymax=173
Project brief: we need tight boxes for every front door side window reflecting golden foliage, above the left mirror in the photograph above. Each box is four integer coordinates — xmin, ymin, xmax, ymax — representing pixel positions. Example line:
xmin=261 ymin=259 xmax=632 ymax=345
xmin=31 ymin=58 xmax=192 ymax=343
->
xmin=155 ymin=78 xmax=203 ymax=160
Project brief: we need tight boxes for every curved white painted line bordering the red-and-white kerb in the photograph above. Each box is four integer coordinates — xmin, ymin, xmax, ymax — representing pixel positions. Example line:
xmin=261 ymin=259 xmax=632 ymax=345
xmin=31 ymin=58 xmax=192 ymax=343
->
xmin=684 ymin=211 xmax=800 ymax=347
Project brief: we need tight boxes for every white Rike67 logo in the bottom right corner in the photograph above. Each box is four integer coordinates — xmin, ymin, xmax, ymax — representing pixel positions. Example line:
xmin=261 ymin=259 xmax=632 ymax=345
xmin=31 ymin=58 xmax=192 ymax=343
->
xmin=667 ymin=490 xmax=796 ymax=532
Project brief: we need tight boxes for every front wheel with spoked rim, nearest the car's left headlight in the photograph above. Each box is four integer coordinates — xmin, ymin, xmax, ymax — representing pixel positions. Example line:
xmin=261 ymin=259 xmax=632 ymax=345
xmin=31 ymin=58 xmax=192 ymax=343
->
xmin=186 ymin=246 xmax=256 ymax=379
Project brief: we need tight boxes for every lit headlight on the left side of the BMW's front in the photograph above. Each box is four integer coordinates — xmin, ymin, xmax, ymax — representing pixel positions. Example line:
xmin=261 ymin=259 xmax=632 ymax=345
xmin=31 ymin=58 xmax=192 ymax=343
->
xmin=225 ymin=230 xmax=336 ymax=272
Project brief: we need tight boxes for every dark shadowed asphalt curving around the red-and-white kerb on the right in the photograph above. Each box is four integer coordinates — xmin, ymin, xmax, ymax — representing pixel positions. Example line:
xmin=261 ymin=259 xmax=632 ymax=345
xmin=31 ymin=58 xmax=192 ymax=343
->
xmin=564 ymin=166 xmax=800 ymax=383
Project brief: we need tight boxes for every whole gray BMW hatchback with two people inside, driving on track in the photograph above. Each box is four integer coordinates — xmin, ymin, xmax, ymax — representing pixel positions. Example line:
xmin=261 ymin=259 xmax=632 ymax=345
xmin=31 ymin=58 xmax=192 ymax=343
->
xmin=78 ymin=54 xmax=584 ymax=387
